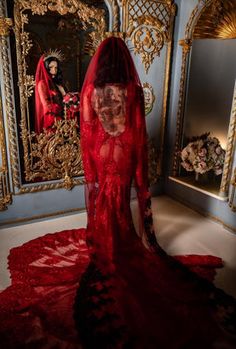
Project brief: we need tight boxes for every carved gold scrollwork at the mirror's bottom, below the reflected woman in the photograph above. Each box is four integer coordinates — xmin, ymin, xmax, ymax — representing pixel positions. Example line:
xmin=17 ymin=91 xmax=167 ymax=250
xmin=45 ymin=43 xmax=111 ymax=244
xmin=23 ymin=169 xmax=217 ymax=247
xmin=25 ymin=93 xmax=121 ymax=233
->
xmin=22 ymin=120 xmax=83 ymax=189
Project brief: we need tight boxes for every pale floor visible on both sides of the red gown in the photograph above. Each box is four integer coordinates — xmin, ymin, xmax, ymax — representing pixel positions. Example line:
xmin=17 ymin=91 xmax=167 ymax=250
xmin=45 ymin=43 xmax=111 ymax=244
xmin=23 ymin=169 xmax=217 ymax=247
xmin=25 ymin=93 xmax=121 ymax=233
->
xmin=0 ymin=196 xmax=236 ymax=297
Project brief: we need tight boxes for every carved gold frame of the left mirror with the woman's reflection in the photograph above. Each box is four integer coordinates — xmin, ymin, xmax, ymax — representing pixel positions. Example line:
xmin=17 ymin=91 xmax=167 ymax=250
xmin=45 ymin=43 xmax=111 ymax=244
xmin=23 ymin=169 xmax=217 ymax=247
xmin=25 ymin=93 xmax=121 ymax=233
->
xmin=0 ymin=0 xmax=119 ymax=194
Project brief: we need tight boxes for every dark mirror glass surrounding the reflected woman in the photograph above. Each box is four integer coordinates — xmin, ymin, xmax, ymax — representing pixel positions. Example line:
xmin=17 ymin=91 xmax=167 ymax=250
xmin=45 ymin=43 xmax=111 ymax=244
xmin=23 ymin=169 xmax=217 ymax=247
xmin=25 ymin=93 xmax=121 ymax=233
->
xmin=25 ymin=11 xmax=85 ymax=132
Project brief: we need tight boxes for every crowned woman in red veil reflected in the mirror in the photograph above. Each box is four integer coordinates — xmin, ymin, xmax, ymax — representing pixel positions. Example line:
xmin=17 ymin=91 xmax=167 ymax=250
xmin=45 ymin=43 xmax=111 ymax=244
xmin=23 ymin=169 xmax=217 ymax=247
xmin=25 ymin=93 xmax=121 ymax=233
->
xmin=35 ymin=51 xmax=66 ymax=133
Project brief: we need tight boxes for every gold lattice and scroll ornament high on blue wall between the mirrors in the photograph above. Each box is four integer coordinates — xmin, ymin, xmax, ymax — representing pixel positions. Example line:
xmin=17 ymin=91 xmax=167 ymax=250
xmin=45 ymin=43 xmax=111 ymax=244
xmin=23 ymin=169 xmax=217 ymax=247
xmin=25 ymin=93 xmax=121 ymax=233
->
xmin=123 ymin=0 xmax=175 ymax=73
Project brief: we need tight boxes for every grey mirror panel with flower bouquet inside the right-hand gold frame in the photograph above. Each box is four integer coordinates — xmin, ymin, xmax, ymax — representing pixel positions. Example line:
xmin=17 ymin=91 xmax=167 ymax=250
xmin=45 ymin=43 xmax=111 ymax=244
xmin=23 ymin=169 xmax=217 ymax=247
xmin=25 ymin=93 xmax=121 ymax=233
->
xmin=179 ymin=39 xmax=236 ymax=194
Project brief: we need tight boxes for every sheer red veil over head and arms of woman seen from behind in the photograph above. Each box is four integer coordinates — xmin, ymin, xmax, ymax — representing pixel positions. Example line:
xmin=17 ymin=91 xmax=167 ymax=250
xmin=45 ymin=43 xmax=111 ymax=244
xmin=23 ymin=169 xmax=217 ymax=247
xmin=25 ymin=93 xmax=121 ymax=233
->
xmin=80 ymin=37 xmax=155 ymax=247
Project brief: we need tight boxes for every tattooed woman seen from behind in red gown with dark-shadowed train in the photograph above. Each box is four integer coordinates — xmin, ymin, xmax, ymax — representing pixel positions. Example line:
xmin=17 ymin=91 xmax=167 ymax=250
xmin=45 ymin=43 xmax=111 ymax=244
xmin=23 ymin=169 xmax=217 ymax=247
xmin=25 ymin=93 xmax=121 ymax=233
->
xmin=75 ymin=37 xmax=236 ymax=349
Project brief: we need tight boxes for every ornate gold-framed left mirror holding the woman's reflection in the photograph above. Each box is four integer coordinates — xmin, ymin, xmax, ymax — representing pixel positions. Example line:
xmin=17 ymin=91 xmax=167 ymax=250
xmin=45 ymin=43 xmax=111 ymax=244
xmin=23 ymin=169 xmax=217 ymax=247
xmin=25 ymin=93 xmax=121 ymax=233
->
xmin=9 ymin=0 xmax=109 ymax=189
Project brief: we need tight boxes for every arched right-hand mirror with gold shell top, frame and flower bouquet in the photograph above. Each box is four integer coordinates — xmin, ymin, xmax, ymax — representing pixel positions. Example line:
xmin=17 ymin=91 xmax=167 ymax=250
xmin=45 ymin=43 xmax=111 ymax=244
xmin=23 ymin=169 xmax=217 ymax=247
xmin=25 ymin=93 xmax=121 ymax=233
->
xmin=173 ymin=1 xmax=236 ymax=197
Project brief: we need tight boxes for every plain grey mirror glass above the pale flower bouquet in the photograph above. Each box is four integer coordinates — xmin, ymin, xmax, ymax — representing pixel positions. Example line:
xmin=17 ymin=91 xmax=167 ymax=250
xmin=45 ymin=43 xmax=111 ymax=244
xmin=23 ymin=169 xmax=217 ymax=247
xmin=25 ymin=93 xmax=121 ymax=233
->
xmin=183 ymin=39 xmax=236 ymax=149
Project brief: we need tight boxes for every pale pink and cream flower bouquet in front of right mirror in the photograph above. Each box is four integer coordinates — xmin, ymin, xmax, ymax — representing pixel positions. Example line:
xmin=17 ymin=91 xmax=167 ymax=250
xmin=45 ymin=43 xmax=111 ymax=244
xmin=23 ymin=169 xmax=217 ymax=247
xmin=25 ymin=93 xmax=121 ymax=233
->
xmin=180 ymin=132 xmax=225 ymax=176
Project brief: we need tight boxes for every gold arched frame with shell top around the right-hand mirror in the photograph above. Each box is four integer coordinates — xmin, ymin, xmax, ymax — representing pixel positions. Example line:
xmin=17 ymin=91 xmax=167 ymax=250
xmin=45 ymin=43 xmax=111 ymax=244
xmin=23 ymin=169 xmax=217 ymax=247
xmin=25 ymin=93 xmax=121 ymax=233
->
xmin=172 ymin=0 xmax=236 ymax=197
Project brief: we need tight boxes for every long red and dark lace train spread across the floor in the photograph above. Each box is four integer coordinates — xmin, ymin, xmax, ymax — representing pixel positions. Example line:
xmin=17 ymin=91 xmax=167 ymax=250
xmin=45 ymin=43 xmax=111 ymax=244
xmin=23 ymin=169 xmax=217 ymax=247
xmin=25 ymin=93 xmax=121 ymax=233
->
xmin=0 ymin=224 xmax=235 ymax=349
